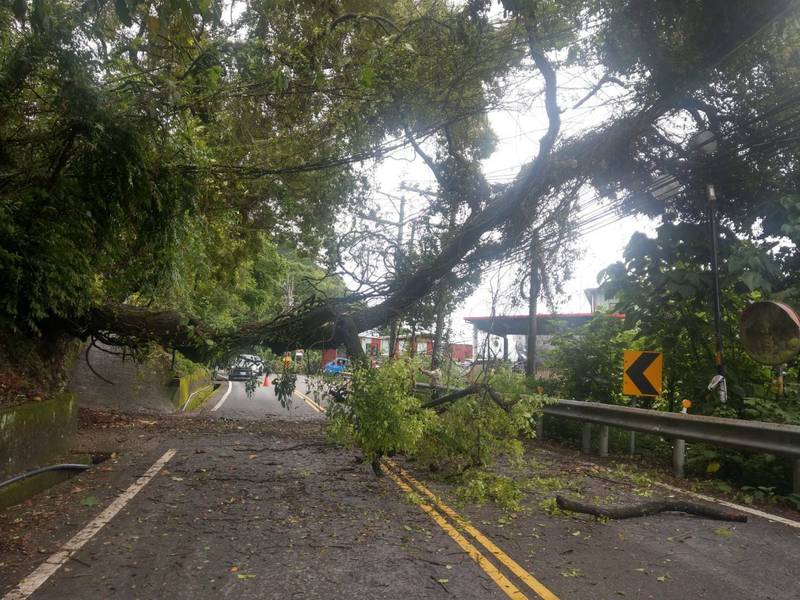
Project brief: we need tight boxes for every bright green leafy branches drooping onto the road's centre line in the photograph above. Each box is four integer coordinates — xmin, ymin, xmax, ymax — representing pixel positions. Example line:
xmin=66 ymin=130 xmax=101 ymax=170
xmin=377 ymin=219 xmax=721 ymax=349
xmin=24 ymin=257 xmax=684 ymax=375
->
xmin=328 ymin=358 xmax=548 ymax=488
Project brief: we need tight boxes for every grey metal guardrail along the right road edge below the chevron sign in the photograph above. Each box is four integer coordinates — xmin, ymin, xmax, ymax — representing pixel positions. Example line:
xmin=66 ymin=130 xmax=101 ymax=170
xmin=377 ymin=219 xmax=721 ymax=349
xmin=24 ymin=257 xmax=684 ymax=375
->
xmin=544 ymin=400 xmax=800 ymax=458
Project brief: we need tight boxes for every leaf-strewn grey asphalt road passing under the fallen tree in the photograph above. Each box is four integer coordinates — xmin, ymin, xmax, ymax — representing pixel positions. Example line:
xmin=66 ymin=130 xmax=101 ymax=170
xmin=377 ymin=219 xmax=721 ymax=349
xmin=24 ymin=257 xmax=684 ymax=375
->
xmin=0 ymin=382 xmax=800 ymax=600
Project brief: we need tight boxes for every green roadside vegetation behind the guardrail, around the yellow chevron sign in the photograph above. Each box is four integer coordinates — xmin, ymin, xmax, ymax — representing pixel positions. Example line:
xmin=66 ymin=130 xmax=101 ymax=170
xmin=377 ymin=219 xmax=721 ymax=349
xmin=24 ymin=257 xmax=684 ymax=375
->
xmin=541 ymin=225 xmax=800 ymax=496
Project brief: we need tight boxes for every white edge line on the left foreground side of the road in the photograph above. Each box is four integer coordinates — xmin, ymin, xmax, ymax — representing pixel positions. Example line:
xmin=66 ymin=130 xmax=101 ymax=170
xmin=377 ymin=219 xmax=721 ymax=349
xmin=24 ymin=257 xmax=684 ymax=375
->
xmin=3 ymin=448 xmax=176 ymax=600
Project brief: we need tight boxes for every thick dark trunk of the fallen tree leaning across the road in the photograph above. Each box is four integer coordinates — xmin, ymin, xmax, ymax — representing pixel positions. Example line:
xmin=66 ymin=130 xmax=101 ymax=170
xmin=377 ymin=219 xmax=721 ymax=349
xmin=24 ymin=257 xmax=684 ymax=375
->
xmin=76 ymin=1 xmax=790 ymax=361
